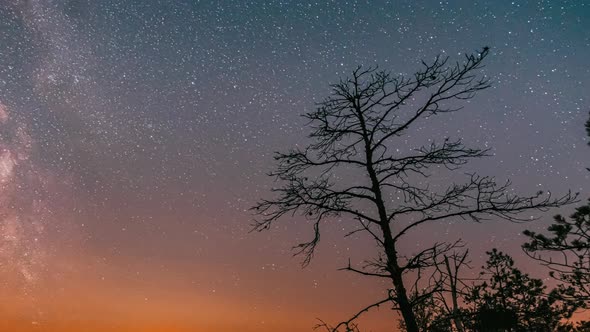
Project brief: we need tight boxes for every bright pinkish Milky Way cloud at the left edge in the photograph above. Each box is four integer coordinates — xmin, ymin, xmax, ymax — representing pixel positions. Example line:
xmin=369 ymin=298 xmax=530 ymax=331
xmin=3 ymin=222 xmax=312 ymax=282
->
xmin=0 ymin=102 xmax=48 ymax=290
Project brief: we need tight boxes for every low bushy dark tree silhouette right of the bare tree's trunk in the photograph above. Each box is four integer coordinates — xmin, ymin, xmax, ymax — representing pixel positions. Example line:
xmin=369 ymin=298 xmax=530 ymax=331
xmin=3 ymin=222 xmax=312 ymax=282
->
xmin=401 ymin=249 xmax=580 ymax=332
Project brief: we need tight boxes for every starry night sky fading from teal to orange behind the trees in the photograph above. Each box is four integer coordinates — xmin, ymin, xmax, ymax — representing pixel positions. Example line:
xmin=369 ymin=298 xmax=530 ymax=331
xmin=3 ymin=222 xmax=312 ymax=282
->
xmin=0 ymin=0 xmax=590 ymax=332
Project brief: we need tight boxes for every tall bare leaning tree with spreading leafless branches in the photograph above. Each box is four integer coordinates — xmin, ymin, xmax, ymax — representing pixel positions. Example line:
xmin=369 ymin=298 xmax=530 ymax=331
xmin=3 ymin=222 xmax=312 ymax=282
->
xmin=253 ymin=47 xmax=573 ymax=332
